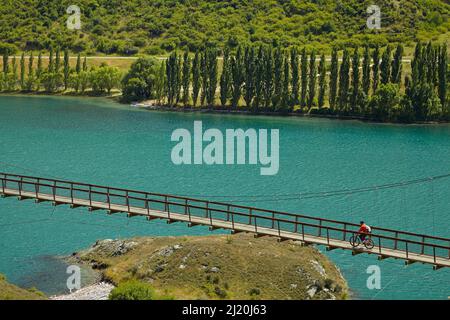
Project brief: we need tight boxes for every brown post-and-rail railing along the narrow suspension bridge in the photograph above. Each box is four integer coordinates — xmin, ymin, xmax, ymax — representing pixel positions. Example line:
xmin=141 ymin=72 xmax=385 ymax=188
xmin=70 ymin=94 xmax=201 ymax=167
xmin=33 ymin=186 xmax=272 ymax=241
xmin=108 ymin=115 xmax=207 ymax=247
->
xmin=0 ymin=173 xmax=450 ymax=262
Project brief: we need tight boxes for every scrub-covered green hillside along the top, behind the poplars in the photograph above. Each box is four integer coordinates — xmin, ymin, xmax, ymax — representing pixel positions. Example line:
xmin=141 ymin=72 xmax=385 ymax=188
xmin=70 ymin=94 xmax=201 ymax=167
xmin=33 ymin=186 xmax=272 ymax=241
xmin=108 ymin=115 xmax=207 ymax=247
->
xmin=0 ymin=0 xmax=450 ymax=55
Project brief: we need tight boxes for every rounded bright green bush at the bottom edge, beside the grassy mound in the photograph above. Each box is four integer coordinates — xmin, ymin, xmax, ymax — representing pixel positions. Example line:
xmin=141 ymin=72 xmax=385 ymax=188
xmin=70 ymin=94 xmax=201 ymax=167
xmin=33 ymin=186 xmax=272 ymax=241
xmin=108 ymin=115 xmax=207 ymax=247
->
xmin=109 ymin=280 xmax=157 ymax=300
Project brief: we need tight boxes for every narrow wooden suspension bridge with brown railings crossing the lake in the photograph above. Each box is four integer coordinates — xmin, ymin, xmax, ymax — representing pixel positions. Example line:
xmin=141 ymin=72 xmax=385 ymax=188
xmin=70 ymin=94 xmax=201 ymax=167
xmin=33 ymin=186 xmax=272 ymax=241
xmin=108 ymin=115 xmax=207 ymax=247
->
xmin=0 ymin=173 xmax=450 ymax=270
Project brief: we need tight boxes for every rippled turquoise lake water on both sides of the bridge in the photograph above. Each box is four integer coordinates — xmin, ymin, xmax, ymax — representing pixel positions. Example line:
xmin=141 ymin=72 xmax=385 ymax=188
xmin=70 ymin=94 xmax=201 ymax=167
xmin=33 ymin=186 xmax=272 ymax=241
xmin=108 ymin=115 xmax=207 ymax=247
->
xmin=0 ymin=96 xmax=450 ymax=299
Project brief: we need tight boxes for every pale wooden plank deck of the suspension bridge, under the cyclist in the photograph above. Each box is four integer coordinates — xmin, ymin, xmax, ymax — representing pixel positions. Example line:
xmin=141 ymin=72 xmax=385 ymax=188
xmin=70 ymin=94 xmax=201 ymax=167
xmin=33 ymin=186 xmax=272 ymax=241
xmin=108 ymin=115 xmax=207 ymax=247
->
xmin=0 ymin=178 xmax=450 ymax=270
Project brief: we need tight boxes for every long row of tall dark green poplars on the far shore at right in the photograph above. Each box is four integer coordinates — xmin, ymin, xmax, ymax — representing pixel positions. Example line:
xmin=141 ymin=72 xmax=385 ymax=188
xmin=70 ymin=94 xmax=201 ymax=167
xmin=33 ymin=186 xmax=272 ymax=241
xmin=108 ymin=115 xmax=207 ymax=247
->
xmin=158 ymin=43 xmax=448 ymax=120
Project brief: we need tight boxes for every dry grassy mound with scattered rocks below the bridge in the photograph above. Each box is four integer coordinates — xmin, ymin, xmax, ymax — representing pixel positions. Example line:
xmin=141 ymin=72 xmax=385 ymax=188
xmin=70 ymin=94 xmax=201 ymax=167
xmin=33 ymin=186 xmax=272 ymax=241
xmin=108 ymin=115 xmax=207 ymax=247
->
xmin=75 ymin=234 xmax=348 ymax=299
